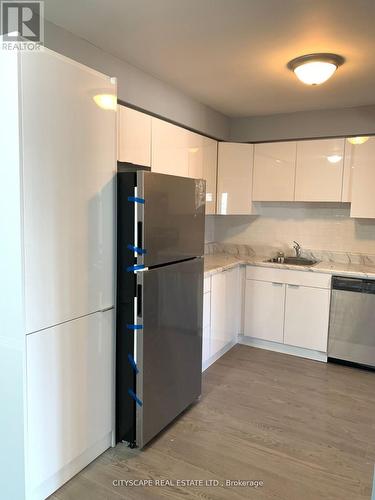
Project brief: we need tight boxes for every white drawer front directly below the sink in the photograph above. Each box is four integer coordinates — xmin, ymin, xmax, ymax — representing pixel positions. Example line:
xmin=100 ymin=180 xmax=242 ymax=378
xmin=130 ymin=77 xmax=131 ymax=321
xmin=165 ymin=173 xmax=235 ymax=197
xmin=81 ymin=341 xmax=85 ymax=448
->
xmin=246 ymin=266 xmax=331 ymax=288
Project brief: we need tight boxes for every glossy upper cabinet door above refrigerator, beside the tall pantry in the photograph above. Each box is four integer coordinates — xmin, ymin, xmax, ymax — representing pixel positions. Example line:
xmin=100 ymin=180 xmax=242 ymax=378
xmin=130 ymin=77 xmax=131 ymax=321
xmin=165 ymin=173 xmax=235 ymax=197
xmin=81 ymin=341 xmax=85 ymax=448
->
xmin=117 ymin=106 xmax=151 ymax=167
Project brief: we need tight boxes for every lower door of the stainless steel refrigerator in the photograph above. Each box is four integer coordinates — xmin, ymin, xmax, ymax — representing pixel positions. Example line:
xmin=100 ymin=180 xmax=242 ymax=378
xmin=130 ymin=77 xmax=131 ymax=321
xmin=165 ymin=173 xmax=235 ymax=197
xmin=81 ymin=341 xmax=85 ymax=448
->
xmin=136 ymin=258 xmax=203 ymax=448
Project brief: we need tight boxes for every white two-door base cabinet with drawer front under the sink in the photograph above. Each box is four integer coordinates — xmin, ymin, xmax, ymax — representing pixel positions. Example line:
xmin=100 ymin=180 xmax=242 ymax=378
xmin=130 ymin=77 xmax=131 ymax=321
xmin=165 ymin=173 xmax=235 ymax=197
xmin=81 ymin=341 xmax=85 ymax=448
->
xmin=244 ymin=266 xmax=331 ymax=353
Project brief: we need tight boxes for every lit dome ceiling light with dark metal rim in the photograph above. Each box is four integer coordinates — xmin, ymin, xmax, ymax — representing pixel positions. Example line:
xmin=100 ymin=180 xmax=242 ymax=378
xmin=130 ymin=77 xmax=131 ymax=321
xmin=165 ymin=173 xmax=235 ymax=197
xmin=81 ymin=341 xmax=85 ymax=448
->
xmin=287 ymin=53 xmax=345 ymax=85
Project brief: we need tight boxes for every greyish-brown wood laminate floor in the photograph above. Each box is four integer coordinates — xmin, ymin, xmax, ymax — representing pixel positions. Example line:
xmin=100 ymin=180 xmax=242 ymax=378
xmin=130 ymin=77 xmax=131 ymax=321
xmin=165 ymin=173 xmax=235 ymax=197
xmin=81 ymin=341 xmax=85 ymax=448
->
xmin=51 ymin=345 xmax=375 ymax=500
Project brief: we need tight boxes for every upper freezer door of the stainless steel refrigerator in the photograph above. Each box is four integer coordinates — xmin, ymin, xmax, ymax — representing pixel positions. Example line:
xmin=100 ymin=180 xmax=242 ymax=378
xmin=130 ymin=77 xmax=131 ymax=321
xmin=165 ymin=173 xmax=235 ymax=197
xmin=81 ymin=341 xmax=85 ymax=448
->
xmin=137 ymin=172 xmax=205 ymax=267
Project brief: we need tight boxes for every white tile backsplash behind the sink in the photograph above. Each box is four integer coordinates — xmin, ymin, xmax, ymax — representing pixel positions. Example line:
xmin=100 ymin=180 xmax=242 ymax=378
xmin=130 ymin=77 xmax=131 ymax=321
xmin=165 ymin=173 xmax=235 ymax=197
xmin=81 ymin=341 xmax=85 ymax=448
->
xmin=206 ymin=203 xmax=375 ymax=254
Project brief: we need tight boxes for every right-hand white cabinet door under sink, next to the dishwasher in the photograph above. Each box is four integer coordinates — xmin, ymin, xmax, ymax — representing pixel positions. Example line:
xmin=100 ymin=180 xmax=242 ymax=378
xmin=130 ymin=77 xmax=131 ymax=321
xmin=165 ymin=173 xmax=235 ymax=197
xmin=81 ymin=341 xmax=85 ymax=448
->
xmin=284 ymin=285 xmax=330 ymax=352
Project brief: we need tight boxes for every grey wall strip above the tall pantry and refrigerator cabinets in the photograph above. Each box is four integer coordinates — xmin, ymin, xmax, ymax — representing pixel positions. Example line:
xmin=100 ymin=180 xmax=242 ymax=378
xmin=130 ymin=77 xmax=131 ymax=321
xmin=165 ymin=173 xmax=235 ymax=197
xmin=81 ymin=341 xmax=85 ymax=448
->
xmin=45 ymin=21 xmax=229 ymax=139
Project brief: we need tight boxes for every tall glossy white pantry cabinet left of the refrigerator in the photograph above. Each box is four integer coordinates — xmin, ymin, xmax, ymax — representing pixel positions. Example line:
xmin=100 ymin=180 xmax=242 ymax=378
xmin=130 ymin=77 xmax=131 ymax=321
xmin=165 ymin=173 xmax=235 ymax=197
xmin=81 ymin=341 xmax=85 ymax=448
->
xmin=0 ymin=49 xmax=116 ymax=500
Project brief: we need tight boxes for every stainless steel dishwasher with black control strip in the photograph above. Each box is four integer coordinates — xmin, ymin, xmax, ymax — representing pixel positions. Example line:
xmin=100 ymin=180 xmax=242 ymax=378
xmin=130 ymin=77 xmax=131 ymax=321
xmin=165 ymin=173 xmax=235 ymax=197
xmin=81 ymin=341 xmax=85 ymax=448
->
xmin=328 ymin=276 xmax=375 ymax=368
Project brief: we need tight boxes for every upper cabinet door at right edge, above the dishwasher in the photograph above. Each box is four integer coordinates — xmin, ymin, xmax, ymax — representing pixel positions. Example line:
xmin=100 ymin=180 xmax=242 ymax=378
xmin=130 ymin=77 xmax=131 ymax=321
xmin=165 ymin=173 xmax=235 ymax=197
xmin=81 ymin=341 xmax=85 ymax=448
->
xmin=348 ymin=137 xmax=375 ymax=218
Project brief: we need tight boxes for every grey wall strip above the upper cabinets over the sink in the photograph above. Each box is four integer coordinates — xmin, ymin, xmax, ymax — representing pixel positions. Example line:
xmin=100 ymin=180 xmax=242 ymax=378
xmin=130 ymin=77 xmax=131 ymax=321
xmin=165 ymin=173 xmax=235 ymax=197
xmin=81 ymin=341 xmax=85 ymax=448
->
xmin=230 ymin=105 xmax=375 ymax=142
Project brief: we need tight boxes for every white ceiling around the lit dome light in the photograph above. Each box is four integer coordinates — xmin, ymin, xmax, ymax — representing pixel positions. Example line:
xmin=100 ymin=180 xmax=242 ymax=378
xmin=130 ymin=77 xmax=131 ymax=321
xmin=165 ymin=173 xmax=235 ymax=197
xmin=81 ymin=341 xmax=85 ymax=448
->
xmin=45 ymin=0 xmax=375 ymax=117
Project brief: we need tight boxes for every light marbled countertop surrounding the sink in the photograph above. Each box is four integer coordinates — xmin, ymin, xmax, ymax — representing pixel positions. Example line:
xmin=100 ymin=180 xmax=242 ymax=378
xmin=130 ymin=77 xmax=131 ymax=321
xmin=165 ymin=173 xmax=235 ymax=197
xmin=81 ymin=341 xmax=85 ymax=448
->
xmin=204 ymin=253 xmax=375 ymax=279
